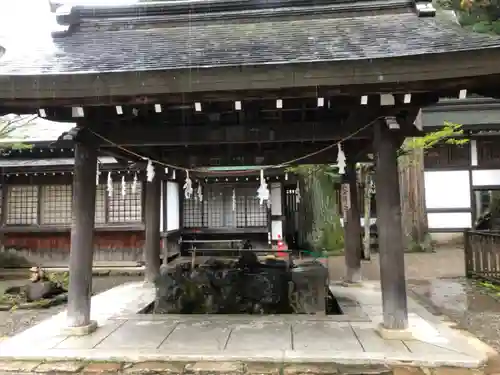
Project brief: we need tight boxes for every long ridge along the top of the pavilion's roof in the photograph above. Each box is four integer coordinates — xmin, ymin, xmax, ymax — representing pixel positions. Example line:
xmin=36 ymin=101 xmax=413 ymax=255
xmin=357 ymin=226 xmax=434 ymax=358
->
xmin=52 ymin=0 xmax=418 ymax=34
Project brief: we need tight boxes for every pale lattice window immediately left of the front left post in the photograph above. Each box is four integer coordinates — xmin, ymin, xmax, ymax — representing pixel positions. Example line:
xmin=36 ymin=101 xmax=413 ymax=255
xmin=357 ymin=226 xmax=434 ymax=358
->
xmin=40 ymin=185 xmax=72 ymax=225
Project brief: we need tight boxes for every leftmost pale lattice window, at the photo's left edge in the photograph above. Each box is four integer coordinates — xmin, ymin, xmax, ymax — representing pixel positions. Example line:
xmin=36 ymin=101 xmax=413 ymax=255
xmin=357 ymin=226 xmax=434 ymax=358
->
xmin=6 ymin=185 xmax=38 ymax=225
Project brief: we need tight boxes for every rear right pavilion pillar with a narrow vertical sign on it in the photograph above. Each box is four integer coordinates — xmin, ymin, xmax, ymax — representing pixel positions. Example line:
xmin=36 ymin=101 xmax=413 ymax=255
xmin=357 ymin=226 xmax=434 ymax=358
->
xmin=343 ymin=162 xmax=362 ymax=283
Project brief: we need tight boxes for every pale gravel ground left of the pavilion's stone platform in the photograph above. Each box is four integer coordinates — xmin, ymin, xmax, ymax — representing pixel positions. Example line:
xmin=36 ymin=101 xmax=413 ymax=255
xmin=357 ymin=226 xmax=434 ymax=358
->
xmin=0 ymin=276 xmax=142 ymax=339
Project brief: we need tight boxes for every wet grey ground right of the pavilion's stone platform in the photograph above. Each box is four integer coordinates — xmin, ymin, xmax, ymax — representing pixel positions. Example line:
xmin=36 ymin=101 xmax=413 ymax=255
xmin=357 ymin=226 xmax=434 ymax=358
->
xmin=408 ymin=278 xmax=500 ymax=351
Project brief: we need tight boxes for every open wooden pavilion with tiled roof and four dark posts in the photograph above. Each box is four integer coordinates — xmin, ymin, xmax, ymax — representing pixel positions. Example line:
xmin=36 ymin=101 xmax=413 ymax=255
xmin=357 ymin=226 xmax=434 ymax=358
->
xmin=0 ymin=0 xmax=500 ymax=333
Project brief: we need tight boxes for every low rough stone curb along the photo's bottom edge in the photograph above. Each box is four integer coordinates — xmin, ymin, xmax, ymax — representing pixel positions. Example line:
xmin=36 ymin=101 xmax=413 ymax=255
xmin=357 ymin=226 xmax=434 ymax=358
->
xmin=0 ymin=360 xmax=491 ymax=375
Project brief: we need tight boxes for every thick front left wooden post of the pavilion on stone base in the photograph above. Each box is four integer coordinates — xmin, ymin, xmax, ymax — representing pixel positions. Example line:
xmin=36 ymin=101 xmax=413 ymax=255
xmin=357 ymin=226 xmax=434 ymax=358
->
xmin=67 ymin=143 xmax=97 ymax=335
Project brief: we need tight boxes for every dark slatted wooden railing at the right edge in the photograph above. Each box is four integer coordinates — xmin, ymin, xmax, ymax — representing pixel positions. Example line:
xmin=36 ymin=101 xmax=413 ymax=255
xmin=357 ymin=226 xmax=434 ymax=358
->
xmin=464 ymin=230 xmax=500 ymax=282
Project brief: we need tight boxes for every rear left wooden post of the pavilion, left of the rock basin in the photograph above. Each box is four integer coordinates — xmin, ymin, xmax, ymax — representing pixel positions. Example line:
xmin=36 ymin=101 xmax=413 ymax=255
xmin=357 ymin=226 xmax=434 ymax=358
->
xmin=144 ymin=167 xmax=163 ymax=282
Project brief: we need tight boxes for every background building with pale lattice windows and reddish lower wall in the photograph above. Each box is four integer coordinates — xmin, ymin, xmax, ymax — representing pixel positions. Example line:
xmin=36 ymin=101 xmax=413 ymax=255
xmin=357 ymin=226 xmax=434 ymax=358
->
xmin=0 ymin=131 xmax=297 ymax=264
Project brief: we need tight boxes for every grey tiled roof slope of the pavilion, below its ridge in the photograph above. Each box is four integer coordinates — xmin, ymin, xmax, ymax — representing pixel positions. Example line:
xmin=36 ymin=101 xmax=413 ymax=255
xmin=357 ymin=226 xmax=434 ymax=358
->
xmin=0 ymin=3 xmax=500 ymax=75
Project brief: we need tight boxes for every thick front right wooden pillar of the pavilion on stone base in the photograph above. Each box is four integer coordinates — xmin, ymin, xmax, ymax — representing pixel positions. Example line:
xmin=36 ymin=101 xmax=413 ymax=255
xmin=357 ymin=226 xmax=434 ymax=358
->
xmin=374 ymin=121 xmax=408 ymax=330
